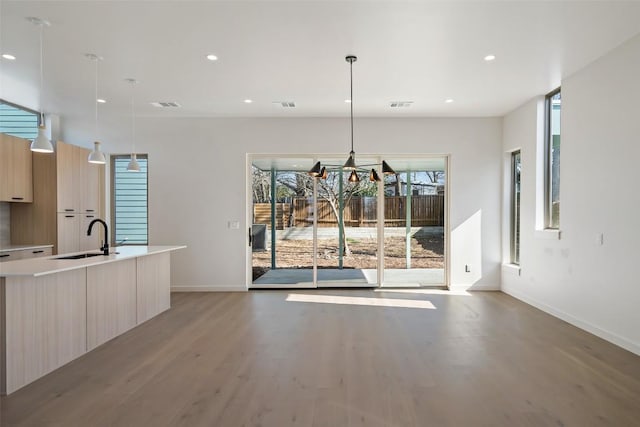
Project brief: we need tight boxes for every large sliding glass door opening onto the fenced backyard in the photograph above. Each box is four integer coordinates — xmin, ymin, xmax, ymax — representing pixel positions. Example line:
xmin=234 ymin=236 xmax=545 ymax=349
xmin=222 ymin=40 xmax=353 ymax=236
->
xmin=249 ymin=156 xmax=446 ymax=288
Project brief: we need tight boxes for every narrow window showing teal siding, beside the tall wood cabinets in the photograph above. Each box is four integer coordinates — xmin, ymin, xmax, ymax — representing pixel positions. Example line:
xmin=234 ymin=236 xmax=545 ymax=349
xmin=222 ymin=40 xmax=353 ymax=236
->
xmin=111 ymin=154 xmax=149 ymax=245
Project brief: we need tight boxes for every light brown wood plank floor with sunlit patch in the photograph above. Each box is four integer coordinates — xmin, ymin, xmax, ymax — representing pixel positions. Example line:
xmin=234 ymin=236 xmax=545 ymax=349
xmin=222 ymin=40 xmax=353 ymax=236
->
xmin=1 ymin=290 xmax=640 ymax=427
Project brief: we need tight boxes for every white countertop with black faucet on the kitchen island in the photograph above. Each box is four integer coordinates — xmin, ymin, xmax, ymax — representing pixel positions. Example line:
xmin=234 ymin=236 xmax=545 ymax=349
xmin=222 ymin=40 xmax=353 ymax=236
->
xmin=0 ymin=246 xmax=186 ymax=277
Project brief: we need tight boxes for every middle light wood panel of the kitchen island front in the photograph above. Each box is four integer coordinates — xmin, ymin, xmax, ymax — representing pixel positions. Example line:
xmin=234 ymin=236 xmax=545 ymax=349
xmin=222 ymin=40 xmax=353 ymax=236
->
xmin=87 ymin=259 xmax=136 ymax=351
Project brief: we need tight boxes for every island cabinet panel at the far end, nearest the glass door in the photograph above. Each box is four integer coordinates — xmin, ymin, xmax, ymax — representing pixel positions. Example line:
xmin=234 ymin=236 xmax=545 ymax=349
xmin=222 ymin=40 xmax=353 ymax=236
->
xmin=137 ymin=252 xmax=171 ymax=324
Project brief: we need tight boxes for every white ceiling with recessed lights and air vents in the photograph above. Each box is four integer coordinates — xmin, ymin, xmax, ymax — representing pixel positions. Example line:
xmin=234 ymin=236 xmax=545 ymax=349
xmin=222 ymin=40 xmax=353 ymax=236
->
xmin=0 ymin=0 xmax=640 ymax=121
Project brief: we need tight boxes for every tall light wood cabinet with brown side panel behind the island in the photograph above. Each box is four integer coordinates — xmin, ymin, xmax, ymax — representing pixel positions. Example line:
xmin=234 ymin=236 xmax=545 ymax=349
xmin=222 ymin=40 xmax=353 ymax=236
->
xmin=11 ymin=141 xmax=104 ymax=253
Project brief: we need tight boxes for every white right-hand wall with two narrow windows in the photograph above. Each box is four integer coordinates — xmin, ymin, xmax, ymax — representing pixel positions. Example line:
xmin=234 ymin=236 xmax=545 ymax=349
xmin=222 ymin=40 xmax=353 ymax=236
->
xmin=502 ymin=32 xmax=640 ymax=354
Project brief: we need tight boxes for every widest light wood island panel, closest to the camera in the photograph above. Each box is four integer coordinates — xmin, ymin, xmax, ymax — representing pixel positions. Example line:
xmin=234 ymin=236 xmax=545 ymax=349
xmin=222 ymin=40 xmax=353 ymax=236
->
xmin=0 ymin=269 xmax=87 ymax=393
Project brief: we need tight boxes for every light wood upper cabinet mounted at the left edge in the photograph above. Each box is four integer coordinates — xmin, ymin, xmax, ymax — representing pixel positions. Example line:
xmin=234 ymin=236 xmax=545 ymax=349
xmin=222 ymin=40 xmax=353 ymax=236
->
xmin=0 ymin=133 xmax=33 ymax=203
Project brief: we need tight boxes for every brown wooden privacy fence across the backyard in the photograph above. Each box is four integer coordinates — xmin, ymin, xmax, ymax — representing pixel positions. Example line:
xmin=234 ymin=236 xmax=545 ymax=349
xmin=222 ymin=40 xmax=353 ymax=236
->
xmin=253 ymin=195 xmax=444 ymax=230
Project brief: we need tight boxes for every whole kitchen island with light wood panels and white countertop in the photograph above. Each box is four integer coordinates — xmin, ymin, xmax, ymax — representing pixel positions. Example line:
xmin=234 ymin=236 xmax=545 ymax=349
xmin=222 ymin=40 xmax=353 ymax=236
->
xmin=0 ymin=246 xmax=185 ymax=394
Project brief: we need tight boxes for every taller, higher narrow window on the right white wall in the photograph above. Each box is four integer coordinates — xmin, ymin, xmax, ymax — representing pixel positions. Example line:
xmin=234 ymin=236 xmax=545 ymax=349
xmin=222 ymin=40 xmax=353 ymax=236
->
xmin=545 ymin=88 xmax=562 ymax=229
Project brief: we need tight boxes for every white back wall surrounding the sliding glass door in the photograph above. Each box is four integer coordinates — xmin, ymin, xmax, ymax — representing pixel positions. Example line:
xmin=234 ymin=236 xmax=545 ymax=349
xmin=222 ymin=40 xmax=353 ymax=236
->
xmin=63 ymin=117 xmax=502 ymax=290
